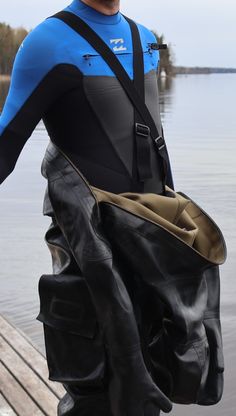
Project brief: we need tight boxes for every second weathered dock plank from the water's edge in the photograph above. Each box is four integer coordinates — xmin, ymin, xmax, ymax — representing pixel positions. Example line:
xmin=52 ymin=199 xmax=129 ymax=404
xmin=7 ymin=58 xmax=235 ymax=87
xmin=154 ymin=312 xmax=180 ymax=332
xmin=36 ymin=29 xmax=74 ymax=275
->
xmin=0 ymin=336 xmax=58 ymax=416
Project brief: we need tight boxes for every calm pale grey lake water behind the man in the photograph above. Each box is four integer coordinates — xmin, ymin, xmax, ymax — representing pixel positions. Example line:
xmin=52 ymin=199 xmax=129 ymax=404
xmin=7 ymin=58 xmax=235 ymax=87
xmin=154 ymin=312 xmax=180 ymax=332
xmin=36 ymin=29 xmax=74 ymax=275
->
xmin=0 ymin=74 xmax=236 ymax=416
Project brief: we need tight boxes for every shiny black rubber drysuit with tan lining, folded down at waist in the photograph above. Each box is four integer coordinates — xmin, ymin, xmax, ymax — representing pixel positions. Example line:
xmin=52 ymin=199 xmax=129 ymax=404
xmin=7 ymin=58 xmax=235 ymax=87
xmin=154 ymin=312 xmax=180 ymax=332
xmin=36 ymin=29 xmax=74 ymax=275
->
xmin=39 ymin=143 xmax=226 ymax=416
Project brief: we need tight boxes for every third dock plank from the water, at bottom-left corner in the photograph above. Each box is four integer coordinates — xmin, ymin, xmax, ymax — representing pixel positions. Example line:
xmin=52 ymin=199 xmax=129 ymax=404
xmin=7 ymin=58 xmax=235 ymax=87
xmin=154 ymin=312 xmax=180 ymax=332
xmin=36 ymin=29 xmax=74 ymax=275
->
xmin=0 ymin=362 xmax=44 ymax=416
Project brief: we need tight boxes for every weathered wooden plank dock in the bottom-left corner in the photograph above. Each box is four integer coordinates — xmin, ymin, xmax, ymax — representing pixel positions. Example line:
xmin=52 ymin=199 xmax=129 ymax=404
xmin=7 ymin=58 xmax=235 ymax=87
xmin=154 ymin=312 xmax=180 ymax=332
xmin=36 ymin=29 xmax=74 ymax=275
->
xmin=0 ymin=315 xmax=65 ymax=416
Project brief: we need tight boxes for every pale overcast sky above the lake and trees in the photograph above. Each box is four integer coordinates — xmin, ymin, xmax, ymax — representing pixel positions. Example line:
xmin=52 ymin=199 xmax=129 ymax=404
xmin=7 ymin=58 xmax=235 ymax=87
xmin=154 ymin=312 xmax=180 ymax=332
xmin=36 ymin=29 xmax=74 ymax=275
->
xmin=0 ymin=0 xmax=236 ymax=68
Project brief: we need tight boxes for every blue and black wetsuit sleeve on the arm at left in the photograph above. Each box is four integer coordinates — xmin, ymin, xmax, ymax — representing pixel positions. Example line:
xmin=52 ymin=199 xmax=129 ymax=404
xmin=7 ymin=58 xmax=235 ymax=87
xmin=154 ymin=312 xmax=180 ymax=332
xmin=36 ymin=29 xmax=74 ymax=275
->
xmin=0 ymin=22 xmax=66 ymax=183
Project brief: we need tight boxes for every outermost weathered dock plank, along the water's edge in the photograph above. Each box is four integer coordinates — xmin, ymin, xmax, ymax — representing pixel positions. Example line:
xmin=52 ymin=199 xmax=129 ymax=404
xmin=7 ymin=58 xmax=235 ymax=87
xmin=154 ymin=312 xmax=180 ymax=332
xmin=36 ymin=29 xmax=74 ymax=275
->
xmin=0 ymin=315 xmax=65 ymax=398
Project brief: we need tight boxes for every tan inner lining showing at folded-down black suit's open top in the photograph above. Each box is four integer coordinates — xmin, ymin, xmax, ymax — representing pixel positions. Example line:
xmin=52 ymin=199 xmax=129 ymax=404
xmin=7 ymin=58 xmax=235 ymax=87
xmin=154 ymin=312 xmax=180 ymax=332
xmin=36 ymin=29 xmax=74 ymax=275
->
xmin=91 ymin=186 xmax=226 ymax=264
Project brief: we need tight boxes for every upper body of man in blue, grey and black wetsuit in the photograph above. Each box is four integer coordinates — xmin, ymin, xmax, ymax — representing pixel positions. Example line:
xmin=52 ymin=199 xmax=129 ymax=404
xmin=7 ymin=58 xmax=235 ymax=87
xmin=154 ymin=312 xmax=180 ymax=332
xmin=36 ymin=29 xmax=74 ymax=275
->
xmin=0 ymin=0 xmax=172 ymax=416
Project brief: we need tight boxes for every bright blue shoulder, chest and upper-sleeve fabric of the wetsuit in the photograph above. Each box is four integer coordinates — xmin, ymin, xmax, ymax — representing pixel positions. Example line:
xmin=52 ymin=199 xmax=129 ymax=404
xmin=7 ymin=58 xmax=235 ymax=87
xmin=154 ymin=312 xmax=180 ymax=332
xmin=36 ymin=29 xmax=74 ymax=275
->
xmin=0 ymin=0 xmax=159 ymax=136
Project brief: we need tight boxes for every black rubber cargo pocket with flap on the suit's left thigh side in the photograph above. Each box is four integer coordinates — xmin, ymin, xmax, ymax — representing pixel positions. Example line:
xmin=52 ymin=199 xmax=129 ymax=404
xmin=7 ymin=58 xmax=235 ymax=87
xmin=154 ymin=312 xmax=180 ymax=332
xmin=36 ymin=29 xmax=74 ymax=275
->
xmin=37 ymin=274 xmax=105 ymax=387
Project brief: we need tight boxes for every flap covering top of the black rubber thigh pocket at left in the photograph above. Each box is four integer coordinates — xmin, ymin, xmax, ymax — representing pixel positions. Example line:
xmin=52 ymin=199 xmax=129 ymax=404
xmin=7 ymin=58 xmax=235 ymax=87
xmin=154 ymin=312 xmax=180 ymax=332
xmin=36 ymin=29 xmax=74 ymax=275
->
xmin=36 ymin=274 xmax=97 ymax=338
